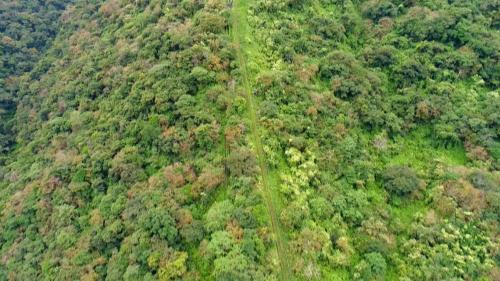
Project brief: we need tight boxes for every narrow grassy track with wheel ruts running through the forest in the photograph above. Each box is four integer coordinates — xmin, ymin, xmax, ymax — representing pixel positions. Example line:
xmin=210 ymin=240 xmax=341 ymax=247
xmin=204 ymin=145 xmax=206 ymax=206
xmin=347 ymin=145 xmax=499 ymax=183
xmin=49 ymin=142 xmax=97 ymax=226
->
xmin=231 ymin=0 xmax=293 ymax=281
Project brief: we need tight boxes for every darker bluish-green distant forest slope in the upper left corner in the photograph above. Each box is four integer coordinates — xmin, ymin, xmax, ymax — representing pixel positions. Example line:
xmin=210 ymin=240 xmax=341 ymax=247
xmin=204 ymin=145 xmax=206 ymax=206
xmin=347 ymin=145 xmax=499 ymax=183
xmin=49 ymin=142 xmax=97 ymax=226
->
xmin=0 ymin=0 xmax=72 ymax=153
